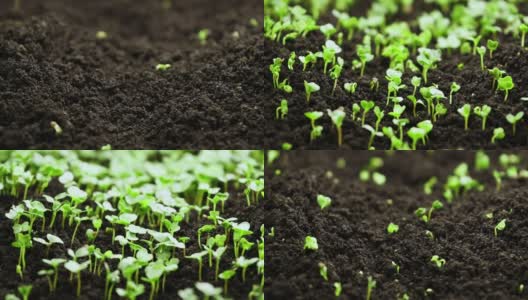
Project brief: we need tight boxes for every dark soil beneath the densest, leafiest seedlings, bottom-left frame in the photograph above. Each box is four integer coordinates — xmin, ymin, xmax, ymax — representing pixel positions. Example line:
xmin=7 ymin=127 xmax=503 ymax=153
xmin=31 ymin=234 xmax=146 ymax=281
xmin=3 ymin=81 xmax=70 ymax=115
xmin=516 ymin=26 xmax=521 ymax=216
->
xmin=0 ymin=182 xmax=264 ymax=300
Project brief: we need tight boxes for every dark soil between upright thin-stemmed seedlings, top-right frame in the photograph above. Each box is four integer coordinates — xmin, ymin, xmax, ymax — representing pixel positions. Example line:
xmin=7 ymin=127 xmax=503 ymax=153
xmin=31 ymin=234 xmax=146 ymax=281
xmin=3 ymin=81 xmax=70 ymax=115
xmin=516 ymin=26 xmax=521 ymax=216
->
xmin=264 ymin=0 xmax=528 ymax=149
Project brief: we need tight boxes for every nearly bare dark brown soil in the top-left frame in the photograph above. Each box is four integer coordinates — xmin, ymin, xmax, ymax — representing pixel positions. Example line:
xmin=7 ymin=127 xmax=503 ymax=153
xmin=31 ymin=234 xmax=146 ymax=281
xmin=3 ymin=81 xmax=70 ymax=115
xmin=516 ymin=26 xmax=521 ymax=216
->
xmin=0 ymin=0 xmax=265 ymax=149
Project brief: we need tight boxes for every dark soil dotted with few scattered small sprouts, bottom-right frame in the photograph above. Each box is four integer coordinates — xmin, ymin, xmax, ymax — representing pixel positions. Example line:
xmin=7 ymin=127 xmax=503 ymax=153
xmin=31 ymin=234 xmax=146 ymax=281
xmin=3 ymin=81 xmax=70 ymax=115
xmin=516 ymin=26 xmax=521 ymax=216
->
xmin=265 ymin=151 xmax=528 ymax=299
